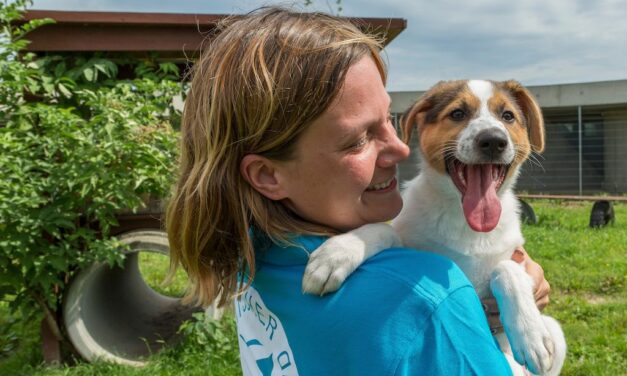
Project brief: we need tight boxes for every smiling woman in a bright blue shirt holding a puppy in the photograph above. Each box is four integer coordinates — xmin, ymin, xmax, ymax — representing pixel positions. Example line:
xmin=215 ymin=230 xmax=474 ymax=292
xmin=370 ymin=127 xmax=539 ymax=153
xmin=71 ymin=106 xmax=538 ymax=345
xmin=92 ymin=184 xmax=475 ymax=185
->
xmin=167 ymin=8 xmax=548 ymax=375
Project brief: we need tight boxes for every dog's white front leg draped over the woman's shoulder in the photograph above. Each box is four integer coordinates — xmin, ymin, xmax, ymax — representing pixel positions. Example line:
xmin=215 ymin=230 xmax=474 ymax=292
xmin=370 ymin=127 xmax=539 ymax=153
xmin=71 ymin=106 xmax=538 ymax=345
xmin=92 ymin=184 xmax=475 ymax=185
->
xmin=303 ymin=223 xmax=402 ymax=295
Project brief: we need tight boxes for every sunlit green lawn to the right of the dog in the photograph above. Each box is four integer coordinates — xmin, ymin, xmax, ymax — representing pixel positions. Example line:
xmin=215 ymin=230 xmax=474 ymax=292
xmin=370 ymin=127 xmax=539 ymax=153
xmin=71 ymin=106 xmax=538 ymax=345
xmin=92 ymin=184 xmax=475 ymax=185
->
xmin=524 ymin=201 xmax=627 ymax=375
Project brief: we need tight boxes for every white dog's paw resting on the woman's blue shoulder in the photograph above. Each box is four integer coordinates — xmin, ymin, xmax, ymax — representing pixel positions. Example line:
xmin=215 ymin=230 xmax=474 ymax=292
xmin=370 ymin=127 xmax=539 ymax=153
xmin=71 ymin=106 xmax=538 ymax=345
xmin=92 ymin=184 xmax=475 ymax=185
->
xmin=303 ymin=234 xmax=365 ymax=295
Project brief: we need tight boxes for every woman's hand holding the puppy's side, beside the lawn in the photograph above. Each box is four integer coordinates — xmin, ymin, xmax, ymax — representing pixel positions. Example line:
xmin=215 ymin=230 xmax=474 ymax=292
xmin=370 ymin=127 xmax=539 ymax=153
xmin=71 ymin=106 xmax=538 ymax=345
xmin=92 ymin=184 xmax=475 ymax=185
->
xmin=481 ymin=247 xmax=551 ymax=334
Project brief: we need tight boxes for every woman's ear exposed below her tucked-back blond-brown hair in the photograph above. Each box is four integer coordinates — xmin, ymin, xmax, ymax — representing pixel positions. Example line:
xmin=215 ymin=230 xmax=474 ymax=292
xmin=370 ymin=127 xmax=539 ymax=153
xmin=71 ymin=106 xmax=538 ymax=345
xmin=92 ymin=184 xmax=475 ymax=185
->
xmin=240 ymin=154 xmax=287 ymax=201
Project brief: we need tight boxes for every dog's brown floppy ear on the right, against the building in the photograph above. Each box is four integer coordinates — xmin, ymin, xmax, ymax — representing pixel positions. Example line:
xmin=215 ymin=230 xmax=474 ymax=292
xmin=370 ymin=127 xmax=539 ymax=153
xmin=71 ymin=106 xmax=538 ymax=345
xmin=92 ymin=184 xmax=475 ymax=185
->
xmin=503 ymin=80 xmax=544 ymax=153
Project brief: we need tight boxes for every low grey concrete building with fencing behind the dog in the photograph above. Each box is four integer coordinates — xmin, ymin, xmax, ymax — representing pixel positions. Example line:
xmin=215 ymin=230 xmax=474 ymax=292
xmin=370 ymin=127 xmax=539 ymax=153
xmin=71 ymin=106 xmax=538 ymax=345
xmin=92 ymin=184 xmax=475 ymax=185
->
xmin=390 ymin=80 xmax=627 ymax=196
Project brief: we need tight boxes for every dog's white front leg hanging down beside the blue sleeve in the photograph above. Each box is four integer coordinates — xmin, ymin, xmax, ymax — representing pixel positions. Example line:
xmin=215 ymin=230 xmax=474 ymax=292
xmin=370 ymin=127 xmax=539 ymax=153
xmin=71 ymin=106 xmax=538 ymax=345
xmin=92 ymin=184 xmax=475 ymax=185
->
xmin=490 ymin=260 xmax=555 ymax=374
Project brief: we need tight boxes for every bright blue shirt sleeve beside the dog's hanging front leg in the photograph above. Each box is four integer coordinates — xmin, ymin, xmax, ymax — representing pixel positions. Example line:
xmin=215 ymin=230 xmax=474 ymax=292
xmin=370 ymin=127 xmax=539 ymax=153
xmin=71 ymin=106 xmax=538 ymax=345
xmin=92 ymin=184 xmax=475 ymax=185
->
xmin=395 ymin=287 xmax=512 ymax=375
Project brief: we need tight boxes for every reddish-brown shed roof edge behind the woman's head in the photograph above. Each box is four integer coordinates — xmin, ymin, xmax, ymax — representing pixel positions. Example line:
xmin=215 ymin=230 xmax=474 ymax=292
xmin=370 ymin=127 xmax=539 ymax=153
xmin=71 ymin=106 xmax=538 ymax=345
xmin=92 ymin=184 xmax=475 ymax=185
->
xmin=18 ymin=10 xmax=407 ymax=60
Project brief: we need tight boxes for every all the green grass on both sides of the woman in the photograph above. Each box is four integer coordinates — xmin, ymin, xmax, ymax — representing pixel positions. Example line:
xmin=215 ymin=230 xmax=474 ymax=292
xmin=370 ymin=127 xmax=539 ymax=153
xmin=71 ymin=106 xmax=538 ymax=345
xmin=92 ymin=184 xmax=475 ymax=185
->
xmin=0 ymin=201 xmax=627 ymax=376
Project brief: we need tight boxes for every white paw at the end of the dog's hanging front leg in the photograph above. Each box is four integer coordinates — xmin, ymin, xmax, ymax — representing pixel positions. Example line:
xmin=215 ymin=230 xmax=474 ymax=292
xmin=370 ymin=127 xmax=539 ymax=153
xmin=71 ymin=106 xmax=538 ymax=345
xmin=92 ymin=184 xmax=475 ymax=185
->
xmin=504 ymin=315 xmax=555 ymax=375
